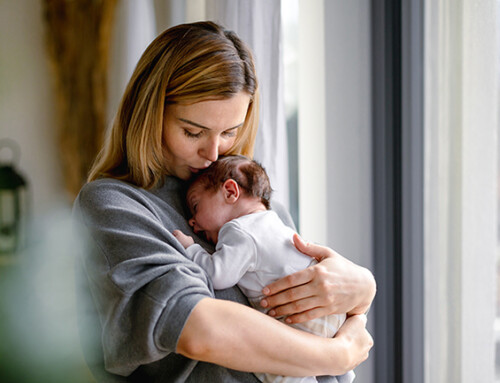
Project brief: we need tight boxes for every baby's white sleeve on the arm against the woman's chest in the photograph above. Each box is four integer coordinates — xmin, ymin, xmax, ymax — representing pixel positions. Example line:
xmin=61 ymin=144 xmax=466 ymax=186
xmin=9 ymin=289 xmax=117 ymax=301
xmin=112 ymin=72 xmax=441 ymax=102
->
xmin=183 ymin=222 xmax=257 ymax=290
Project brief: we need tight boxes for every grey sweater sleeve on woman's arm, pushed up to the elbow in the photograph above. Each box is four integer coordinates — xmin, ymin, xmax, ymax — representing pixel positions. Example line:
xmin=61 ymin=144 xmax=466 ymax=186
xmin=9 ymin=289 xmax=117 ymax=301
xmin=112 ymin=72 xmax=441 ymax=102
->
xmin=74 ymin=182 xmax=213 ymax=376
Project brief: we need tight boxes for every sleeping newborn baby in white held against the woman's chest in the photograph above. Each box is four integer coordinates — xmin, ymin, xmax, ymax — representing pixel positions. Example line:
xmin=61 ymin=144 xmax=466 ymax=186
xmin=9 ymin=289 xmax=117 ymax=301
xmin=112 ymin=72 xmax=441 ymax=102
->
xmin=173 ymin=156 xmax=354 ymax=383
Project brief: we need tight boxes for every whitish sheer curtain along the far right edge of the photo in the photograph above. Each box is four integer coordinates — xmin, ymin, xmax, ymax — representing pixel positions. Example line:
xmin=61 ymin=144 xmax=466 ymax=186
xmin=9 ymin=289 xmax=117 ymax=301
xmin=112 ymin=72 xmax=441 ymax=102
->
xmin=424 ymin=0 xmax=499 ymax=383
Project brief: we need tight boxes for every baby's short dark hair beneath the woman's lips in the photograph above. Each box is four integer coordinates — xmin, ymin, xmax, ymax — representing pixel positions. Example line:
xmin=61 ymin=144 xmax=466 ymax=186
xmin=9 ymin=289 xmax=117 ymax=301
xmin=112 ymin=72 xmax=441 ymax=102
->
xmin=191 ymin=155 xmax=272 ymax=210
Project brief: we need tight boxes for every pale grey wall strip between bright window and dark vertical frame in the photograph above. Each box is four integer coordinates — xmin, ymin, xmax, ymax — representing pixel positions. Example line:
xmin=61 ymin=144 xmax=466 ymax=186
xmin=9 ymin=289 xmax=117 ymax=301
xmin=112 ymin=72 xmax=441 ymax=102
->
xmin=324 ymin=0 xmax=374 ymax=383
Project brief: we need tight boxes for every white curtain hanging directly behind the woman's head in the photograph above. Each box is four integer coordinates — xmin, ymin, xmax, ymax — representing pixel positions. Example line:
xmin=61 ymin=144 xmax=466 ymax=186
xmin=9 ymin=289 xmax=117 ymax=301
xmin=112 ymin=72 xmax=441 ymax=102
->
xmin=206 ymin=0 xmax=289 ymax=207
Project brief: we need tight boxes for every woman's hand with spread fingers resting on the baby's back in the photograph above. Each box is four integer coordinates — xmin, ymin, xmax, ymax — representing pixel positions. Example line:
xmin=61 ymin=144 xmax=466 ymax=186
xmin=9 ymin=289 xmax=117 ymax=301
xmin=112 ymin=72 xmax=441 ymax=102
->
xmin=261 ymin=234 xmax=376 ymax=323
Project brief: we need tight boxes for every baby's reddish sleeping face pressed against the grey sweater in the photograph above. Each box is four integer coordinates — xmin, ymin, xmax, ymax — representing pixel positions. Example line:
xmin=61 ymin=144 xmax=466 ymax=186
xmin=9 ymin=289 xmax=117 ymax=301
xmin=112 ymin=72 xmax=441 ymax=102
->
xmin=187 ymin=183 xmax=232 ymax=243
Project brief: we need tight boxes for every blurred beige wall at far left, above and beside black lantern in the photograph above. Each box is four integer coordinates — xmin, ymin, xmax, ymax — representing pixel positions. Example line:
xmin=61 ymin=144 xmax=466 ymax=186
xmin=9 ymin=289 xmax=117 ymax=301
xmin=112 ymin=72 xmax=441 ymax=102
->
xmin=0 ymin=0 xmax=67 ymax=215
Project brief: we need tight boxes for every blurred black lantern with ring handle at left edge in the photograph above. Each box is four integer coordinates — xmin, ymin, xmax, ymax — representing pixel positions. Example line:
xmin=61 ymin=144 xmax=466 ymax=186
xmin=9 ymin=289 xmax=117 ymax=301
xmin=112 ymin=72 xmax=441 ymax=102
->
xmin=0 ymin=138 xmax=27 ymax=254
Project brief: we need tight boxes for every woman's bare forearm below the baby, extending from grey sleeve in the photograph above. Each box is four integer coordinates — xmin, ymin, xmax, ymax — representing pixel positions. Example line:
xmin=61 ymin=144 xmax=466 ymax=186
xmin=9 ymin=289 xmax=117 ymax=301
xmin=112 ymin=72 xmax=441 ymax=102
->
xmin=177 ymin=298 xmax=354 ymax=376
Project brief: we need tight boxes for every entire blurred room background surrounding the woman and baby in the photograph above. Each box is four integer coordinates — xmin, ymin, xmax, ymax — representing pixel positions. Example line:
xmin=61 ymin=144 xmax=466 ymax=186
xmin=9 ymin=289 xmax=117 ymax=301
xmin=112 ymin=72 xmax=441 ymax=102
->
xmin=0 ymin=0 xmax=500 ymax=383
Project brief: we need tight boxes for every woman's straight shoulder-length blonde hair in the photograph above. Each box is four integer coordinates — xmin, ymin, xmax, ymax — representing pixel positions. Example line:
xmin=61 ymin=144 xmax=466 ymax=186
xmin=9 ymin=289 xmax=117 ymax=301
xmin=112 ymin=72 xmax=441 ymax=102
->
xmin=88 ymin=21 xmax=259 ymax=189
